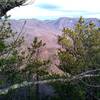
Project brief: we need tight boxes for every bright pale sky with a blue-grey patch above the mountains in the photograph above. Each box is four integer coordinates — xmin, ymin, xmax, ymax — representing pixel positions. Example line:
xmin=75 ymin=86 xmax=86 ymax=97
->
xmin=7 ymin=0 xmax=100 ymax=20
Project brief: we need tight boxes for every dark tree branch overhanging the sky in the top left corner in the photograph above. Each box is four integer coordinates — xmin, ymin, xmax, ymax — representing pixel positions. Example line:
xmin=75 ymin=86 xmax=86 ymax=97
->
xmin=0 ymin=0 xmax=35 ymax=17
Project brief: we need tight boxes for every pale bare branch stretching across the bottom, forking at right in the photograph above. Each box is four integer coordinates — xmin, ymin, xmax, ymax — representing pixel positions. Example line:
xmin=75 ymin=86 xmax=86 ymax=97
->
xmin=0 ymin=69 xmax=100 ymax=94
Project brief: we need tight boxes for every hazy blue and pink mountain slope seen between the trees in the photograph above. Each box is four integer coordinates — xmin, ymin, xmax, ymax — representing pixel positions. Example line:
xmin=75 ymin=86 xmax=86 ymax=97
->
xmin=11 ymin=17 xmax=100 ymax=73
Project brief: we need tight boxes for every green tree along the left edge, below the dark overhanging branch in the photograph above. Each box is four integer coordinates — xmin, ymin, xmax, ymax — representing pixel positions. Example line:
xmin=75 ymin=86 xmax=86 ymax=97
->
xmin=0 ymin=16 xmax=24 ymax=84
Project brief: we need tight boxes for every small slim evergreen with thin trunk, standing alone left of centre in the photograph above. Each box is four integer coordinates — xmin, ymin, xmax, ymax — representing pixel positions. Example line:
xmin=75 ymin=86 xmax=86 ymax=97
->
xmin=23 ymin=37 xmax=50 ymax=100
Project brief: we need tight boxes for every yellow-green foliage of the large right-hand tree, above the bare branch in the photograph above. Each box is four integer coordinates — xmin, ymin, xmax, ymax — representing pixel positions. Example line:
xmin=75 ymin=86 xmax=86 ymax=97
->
xmin=58 ymin=17 xmax=100 ymax=74
